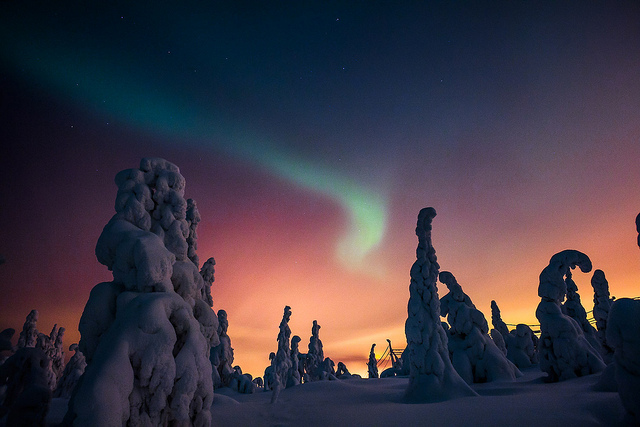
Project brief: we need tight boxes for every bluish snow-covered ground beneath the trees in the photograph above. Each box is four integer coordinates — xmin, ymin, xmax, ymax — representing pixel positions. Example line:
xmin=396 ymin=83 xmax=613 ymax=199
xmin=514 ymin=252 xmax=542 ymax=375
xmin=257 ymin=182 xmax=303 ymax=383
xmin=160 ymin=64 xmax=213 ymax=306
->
xmin=47 ymin=366 xmax=633 ymax=427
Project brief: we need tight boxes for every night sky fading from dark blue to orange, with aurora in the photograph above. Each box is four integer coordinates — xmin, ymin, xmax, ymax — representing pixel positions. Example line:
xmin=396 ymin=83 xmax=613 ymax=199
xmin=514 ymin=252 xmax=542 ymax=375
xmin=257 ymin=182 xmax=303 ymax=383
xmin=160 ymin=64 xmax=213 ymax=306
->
xmin=0 ymin=1 xmax=640 ymax=375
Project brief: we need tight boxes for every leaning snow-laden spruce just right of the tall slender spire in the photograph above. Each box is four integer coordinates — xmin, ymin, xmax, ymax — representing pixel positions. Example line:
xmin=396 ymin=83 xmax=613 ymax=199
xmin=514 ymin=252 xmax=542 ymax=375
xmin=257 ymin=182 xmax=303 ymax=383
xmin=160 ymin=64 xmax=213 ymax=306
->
xmin=439 ymin=271 xmax=522 ymax=384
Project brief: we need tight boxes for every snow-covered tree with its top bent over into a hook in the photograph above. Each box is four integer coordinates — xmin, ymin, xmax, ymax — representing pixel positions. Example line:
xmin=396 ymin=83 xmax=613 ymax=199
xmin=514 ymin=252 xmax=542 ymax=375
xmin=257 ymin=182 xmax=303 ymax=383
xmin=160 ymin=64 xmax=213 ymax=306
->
xmin=536 ymin=249 xmax=605 ymax=381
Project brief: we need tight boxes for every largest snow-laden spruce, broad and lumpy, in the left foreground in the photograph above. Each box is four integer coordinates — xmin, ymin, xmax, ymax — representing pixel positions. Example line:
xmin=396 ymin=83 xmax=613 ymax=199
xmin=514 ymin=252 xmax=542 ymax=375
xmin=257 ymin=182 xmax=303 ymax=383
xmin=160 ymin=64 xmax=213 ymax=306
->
xmin=65 ymin=158 xmax=219 ymax=426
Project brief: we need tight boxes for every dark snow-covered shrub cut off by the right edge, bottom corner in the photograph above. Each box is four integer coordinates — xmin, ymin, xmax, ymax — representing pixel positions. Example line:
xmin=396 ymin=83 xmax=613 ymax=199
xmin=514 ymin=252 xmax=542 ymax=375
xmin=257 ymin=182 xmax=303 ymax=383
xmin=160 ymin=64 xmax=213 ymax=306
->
xmin=607 ymin=298 xmax=640 ymax=424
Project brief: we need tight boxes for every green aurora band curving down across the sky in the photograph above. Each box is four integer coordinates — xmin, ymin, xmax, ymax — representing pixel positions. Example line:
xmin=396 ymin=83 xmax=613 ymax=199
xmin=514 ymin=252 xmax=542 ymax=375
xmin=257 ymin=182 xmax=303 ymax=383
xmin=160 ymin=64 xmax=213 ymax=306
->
xmin=0 ymin=28 xmax=387 ymax=274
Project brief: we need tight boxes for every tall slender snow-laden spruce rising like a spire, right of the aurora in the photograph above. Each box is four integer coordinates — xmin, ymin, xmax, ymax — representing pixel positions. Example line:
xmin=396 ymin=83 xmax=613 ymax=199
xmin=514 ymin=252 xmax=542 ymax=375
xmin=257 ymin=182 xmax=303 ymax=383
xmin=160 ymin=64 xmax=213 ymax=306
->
xmin=404 ymin=208 xmax=477 ymax=403
